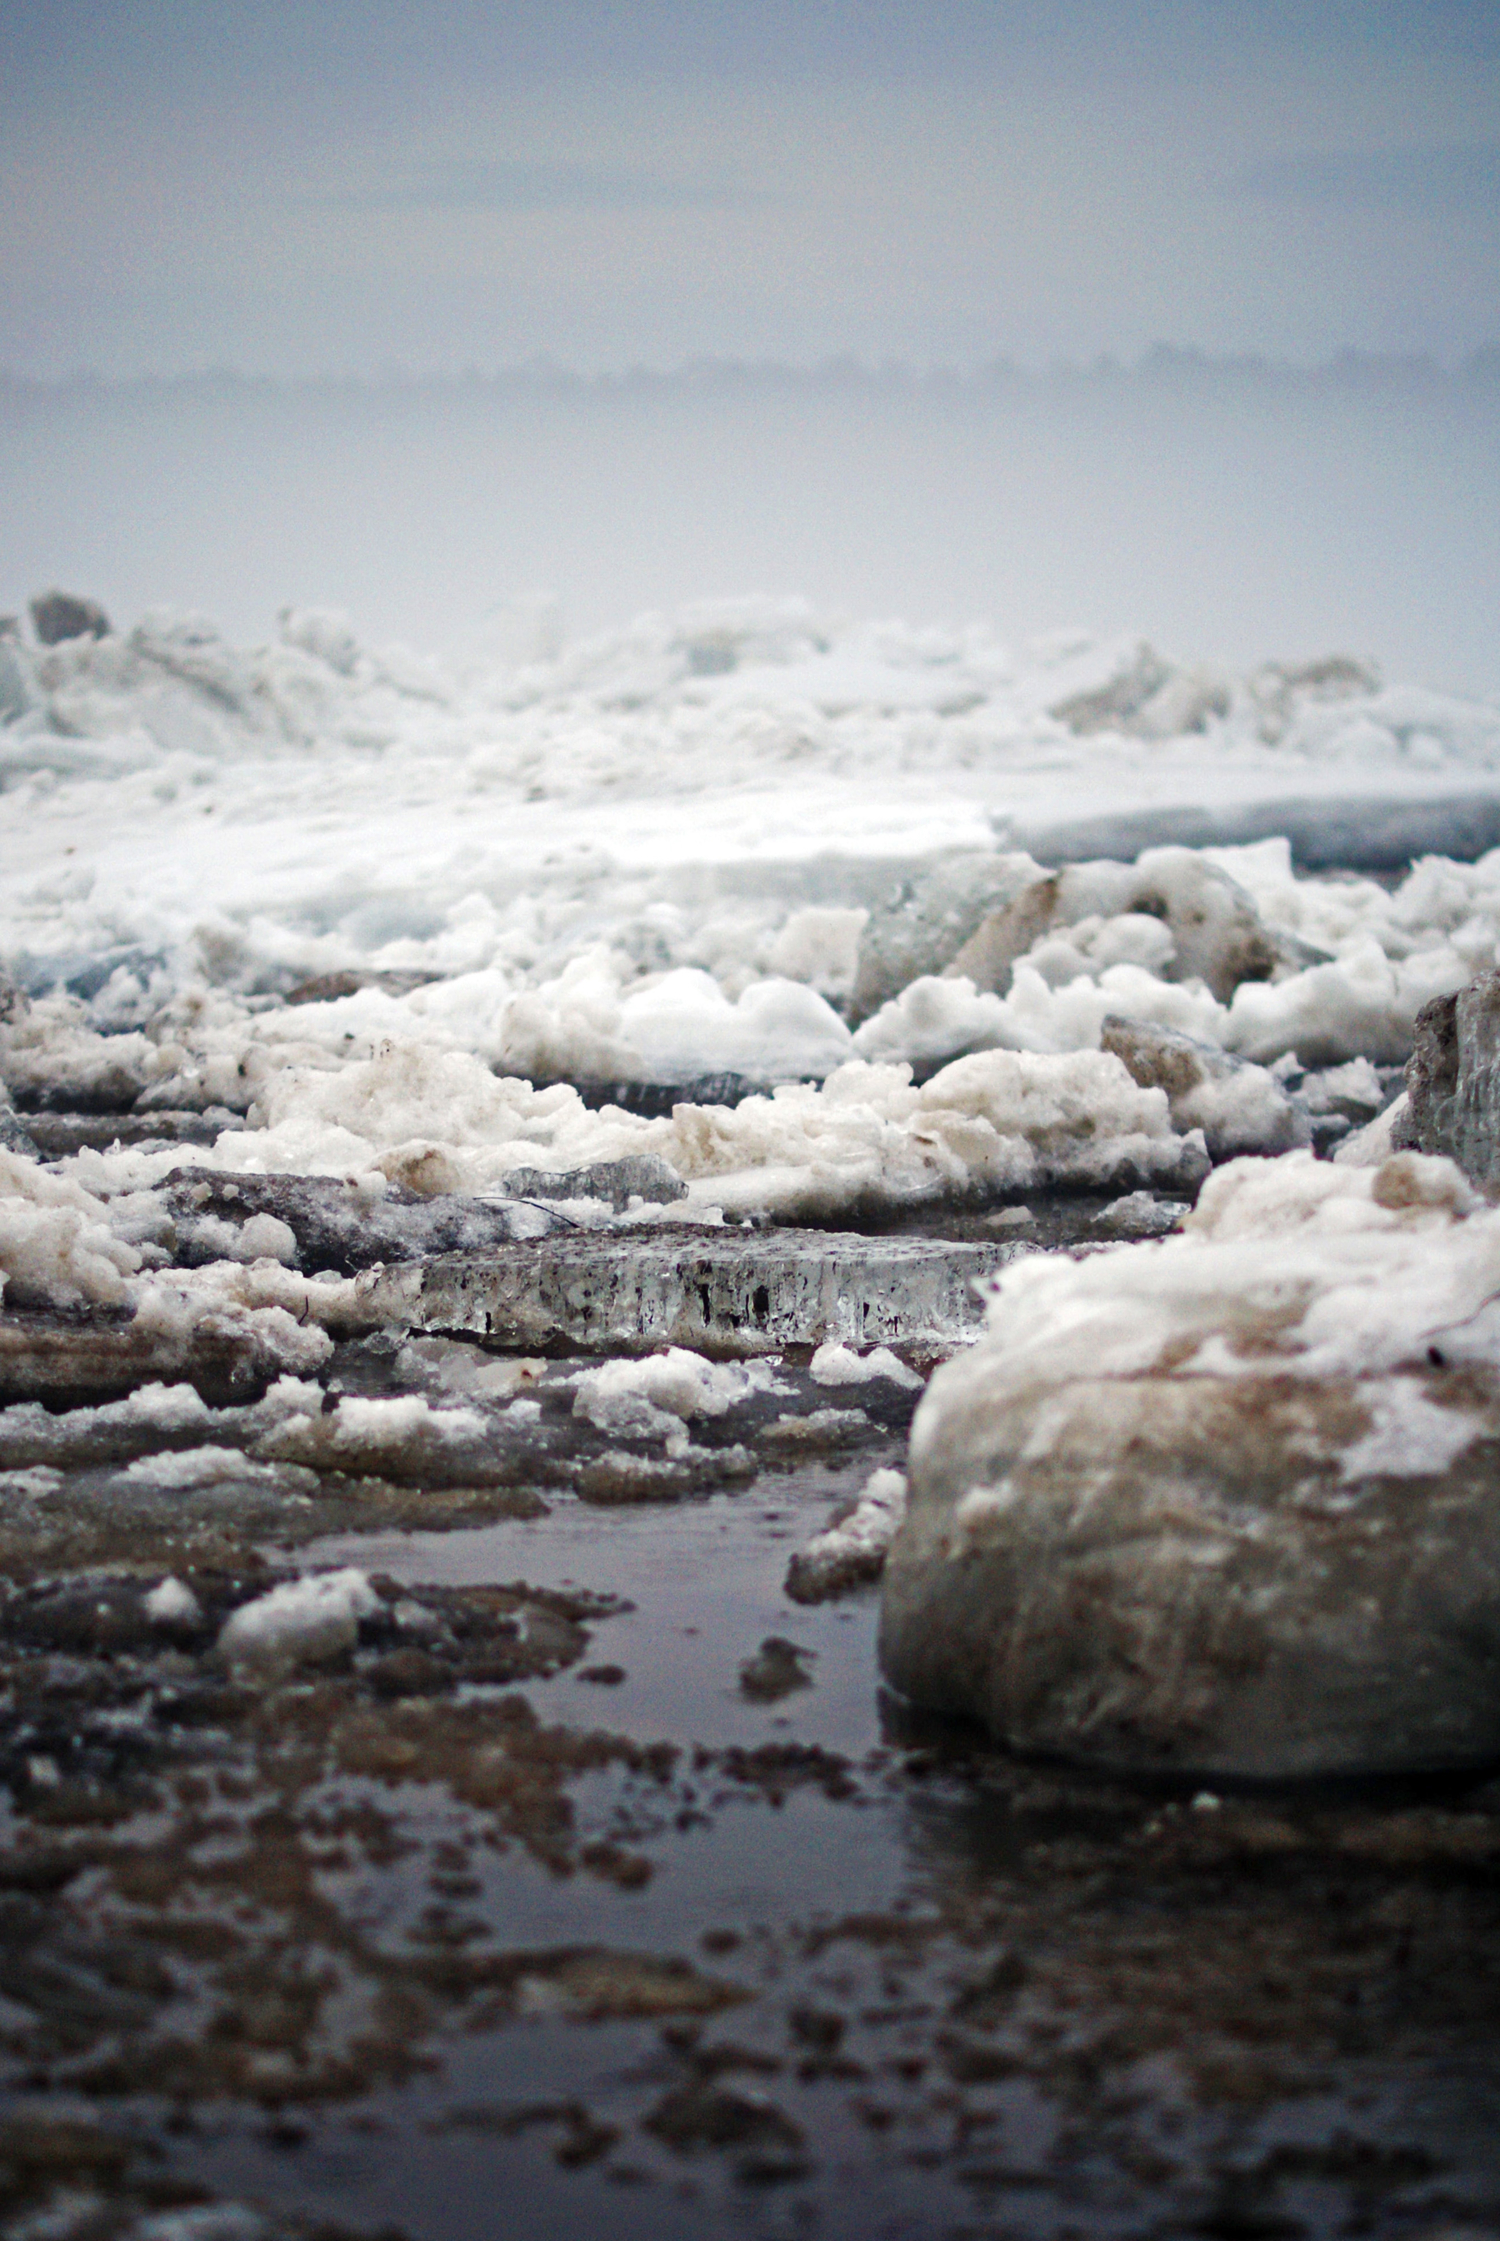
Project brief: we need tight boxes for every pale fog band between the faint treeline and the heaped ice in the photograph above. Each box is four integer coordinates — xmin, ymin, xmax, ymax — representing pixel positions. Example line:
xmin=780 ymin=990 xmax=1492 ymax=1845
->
xmin=0 ymin=352 xmax=1500 ymax=695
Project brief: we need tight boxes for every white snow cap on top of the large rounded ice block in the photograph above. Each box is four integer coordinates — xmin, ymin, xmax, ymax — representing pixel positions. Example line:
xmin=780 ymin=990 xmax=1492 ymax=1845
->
xmin=910 ymin=1152 xmax=1500 ymax=1531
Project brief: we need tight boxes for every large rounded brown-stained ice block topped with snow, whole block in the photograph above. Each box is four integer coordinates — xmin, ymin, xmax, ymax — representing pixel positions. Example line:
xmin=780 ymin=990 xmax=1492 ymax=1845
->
xmin=881 ymin=1152 xmax=1500 ymax=1777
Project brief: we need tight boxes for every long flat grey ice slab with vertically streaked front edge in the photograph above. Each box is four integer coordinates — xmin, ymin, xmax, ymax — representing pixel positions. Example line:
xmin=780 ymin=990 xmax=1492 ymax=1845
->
xmin=359 ymin=1230 xmax=1025 ymax=1356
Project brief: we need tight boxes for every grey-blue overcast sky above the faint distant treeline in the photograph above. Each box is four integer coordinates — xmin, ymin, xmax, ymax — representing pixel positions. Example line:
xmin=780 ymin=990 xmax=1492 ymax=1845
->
xmin=0 ymin=0 xmax=1500 ymax=376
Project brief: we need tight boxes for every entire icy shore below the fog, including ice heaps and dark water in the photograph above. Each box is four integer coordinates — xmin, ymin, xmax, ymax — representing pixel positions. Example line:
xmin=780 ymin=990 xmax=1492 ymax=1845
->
xmin=0 ymin=603 xmax=1500 ymax=2241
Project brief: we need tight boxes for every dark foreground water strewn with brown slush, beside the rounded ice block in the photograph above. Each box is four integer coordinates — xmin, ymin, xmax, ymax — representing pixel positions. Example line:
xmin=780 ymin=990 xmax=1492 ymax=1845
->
xmin=0 ymin=1363 xmax=1500 ymax=2241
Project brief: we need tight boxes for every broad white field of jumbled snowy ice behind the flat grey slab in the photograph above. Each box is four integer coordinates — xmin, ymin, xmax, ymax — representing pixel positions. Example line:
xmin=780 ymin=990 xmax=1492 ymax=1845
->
xmin=0 ymin=598 xmax=1500 ymax=1219
